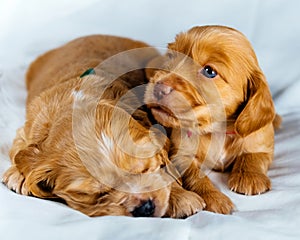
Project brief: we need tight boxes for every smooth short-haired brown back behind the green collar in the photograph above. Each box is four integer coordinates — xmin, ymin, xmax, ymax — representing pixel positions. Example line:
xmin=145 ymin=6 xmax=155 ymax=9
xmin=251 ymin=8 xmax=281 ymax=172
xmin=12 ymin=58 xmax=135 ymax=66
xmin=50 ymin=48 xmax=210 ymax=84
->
xmin=26 ymin=35 xmax=157 ymax=103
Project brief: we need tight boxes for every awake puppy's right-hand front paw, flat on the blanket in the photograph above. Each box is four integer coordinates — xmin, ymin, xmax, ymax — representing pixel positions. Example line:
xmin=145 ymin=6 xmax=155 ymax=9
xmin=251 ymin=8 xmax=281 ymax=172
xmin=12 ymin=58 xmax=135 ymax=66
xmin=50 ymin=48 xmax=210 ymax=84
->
xmin=228 ymin=172 xmax=271 ymax=195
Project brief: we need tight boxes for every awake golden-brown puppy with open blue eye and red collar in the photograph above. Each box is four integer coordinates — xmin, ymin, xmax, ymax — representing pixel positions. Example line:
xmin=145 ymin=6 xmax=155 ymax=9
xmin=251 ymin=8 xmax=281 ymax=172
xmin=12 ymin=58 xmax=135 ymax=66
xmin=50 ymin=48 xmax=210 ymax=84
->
xmin=145 ymin=26 xmax=280 ymax=214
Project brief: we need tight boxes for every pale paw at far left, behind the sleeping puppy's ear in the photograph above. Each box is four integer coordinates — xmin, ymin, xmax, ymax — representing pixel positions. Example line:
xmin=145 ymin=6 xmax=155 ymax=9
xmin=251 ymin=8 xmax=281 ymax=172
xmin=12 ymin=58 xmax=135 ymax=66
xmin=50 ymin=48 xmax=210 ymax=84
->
xmin=2 ymin=165 xmax=29 ymax=195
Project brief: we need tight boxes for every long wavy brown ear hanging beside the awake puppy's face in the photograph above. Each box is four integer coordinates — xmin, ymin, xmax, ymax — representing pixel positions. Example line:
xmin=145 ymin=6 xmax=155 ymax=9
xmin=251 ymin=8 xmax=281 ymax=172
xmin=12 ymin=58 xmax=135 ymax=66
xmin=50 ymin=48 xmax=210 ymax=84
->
xmin=235 ymin=70 xmax=275 ymax=137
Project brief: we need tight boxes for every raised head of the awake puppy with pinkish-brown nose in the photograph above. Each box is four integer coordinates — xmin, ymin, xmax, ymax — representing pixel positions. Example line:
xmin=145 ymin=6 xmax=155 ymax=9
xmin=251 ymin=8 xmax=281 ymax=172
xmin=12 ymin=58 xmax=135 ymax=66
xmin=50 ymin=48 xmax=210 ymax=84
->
xmin=145 ymin=26 xmax=275 ymax=136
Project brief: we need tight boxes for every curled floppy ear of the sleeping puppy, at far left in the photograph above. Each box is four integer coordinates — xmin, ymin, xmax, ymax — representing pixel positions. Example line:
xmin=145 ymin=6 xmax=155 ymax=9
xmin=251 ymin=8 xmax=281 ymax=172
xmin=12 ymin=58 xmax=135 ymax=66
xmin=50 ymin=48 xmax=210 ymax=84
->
xmin=15 ymin=144 xmax=55 ymax=198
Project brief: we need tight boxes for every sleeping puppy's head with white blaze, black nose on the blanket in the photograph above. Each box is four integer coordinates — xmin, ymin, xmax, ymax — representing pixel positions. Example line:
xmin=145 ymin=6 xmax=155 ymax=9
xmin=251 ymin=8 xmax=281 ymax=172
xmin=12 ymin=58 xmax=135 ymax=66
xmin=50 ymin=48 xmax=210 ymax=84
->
xmin=14 ymin=101 xmax=172 ymax=217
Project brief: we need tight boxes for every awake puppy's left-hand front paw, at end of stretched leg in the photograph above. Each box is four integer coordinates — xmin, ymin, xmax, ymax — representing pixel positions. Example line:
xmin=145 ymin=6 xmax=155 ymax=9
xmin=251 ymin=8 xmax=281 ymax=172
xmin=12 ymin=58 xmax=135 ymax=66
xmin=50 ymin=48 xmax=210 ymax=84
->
xmin=201 ymin=191 xmax=234 ymax=214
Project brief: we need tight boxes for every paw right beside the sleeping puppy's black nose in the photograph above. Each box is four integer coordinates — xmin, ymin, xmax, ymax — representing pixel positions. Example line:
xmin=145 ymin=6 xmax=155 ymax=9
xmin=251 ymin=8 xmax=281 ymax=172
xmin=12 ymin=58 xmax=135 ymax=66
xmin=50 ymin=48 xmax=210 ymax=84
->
xmin=165 ymin=189 xmax=205 ymax=218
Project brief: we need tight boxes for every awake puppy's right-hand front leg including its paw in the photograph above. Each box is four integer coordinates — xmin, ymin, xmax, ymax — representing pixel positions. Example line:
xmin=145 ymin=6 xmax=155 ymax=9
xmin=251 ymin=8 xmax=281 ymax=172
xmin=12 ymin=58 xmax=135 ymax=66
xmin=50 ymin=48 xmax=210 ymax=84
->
xmin=228 ymin=153 xmax=272 ymax=195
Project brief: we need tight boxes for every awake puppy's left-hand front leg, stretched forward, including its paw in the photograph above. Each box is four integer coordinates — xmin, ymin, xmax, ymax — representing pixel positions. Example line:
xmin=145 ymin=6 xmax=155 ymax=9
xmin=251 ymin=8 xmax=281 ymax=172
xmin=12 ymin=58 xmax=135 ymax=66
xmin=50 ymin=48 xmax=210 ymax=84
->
xmin=183 ymin=162 xmax=234 ymax=214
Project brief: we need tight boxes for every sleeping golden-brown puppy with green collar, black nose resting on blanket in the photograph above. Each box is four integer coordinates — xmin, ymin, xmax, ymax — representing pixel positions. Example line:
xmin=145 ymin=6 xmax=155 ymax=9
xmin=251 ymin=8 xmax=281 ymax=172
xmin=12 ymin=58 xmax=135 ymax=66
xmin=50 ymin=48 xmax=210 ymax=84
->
xmin=3 ymin=35 xmax=205 ymax=218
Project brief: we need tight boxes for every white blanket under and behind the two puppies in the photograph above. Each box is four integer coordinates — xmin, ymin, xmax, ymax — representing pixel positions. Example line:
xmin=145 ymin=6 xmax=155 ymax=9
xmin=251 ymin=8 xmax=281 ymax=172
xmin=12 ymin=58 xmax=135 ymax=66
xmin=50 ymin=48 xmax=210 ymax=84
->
xmin=0 ymin=0 xmax=300 ymax=240
